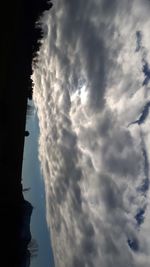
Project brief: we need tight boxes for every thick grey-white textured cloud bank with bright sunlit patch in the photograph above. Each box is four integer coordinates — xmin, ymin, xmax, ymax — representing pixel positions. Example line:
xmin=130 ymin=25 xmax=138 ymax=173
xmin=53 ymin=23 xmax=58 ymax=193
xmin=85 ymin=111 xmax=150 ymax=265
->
xmin=32 ymin=0 xmax=150 ymax=267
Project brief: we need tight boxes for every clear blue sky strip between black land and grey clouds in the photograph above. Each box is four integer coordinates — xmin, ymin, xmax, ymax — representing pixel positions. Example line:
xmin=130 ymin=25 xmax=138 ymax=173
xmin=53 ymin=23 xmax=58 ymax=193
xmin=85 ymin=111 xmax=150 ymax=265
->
xmin=22 ymin=111 xmax=54 ymax=267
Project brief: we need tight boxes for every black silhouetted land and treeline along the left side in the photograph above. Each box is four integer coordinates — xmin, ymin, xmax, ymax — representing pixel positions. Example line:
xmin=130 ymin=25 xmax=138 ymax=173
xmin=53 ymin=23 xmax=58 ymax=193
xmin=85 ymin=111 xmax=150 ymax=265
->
xmin=0 ymin=0 xmax=52 ymax=267
